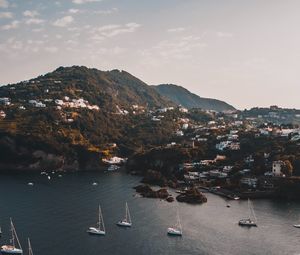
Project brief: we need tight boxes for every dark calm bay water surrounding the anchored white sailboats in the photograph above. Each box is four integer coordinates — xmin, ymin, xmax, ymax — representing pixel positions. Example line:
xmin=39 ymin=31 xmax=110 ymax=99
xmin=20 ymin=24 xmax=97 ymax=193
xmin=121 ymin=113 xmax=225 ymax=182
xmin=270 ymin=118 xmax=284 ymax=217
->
xmin=0 ymin=173 xmax=300 ymax=255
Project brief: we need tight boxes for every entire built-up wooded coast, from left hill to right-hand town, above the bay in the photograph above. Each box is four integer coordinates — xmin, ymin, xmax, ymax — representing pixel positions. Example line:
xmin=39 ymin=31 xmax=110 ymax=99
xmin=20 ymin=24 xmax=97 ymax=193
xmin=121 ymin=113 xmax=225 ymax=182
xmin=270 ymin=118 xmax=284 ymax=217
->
xmin=0 ymin=68 xmax=300 ymax=200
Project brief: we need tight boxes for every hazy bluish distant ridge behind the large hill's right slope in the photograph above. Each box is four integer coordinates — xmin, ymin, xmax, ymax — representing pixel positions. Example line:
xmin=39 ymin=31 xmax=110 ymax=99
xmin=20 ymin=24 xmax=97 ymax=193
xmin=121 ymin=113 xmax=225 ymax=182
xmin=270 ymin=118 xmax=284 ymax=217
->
xmin=152 ymin=84 xmax=235 ymax=112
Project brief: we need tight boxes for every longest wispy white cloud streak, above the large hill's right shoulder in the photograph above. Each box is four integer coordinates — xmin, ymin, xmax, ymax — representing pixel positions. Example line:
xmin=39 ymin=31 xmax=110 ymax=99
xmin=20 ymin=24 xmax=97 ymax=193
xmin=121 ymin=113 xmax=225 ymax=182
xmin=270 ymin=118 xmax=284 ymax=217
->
xmin=95 ymin=23 xmax=141 ymax=37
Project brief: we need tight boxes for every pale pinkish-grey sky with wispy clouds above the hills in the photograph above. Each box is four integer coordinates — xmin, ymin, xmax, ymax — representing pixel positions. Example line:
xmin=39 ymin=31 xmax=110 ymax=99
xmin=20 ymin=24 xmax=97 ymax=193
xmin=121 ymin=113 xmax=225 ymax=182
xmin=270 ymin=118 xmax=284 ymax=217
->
xmin=0 ymin=0 xmax=300 ymax=109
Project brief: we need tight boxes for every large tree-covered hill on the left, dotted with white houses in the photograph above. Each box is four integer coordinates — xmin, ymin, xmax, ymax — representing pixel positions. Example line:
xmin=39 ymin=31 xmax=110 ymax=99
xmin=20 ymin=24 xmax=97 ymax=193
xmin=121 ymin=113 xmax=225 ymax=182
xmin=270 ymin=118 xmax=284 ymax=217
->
xmin=0 ymin=66 xmax=189 ymax=170
